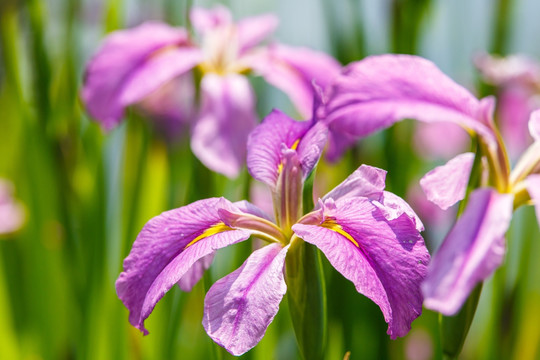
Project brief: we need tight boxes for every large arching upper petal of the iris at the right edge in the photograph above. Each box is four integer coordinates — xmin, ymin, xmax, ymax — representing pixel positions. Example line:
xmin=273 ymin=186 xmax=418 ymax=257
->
xmin=328 ymin=55 xmax=495 ymax=144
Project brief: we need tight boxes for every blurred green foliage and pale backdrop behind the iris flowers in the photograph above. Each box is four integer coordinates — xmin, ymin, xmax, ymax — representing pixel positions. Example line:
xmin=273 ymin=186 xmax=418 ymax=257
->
xmin=0 ymin=0 xmax=540 ymax=360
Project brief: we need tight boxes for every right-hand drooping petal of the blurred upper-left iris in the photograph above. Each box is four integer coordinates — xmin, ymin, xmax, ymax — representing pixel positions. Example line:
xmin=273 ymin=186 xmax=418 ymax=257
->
xmin=250 ymin=44 xmax=341 ymax=119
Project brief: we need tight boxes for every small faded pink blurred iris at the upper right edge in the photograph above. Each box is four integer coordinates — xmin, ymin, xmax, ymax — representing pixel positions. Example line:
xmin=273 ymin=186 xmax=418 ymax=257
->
xmin=474 ymin=54 xmax=540 ymax=159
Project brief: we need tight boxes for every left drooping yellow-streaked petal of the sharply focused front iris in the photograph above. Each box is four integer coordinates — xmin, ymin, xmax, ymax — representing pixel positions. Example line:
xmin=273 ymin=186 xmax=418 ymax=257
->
xmin=116 ymin=198 xmax=250 ymax=334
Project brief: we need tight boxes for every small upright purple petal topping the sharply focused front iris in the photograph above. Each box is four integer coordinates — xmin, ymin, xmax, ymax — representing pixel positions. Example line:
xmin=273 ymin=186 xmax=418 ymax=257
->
xmin=247 ymin=110 xmax=327 ymax=188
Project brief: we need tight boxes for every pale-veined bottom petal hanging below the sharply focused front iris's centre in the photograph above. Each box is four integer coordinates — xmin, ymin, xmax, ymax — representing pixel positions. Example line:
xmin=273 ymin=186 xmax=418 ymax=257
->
xmin=203 ymin=244 xmax=289 ymax=356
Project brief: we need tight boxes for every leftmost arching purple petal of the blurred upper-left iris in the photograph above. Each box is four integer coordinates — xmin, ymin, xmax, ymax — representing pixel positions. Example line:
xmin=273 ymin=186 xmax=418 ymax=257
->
xmin=81 ymin=23 xmax=188 ymax=129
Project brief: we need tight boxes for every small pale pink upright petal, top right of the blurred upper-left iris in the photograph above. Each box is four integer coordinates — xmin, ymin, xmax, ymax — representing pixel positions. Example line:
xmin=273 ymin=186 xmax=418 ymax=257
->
xmin=236 ymin=14 xmax=279 ymax=53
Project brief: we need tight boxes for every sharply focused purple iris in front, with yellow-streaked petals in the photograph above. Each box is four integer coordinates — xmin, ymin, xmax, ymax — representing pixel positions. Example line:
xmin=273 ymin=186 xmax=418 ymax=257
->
xmin=116 ymin=106 xmax=429 ymax=355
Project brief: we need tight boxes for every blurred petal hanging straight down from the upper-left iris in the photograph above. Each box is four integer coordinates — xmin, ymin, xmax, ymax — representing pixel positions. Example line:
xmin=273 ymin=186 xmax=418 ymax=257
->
xmin=191 ymin=73 xmax=257 ymax=178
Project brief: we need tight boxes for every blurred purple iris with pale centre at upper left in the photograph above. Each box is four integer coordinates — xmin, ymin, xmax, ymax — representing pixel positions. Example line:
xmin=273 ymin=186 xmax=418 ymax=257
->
xmin=82 ymin=6 xmax=340 ymax=177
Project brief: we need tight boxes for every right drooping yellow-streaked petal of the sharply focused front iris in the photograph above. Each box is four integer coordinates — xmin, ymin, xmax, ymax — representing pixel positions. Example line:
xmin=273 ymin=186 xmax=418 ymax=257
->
xmin=293 ymin=197 xmax=429 ymax=339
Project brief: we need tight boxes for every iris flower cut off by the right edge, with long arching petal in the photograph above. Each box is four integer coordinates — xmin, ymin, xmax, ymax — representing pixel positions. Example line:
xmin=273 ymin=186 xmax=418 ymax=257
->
xmin=322 ymin=55 xmax=540 ymax=315
